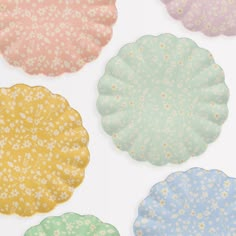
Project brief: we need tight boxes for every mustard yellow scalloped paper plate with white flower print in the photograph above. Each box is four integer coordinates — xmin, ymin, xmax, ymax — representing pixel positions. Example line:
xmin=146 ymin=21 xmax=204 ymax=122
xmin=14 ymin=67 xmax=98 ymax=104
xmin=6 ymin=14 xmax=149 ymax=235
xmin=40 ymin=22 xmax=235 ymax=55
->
xmin=0 ymin=85 xmax=89 ymax=216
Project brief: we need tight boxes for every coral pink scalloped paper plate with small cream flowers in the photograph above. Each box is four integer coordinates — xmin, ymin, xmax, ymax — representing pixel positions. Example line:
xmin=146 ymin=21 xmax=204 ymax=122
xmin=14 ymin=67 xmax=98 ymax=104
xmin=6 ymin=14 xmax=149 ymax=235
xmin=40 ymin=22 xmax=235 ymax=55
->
xmin=0 ymin=0 xmax=117 ymax=76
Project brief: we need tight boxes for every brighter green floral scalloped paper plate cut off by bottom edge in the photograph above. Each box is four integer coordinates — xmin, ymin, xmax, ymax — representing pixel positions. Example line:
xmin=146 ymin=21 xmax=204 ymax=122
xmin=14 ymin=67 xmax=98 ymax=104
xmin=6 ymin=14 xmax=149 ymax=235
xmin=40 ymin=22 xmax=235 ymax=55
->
xmin=25 ymin=213 xmax=120 ymax=236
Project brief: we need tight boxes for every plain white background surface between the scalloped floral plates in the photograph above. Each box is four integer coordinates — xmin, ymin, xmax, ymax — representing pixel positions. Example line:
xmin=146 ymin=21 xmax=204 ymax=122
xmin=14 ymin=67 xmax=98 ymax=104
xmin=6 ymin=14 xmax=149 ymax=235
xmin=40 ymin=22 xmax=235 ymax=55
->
xmin=0 ymin=0 xmax=236 ymax=236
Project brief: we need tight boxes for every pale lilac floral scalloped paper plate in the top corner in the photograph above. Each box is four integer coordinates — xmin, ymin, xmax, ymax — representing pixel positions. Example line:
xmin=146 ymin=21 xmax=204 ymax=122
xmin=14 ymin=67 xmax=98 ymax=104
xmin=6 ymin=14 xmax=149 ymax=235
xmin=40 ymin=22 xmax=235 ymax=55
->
xmin=161 ymin=0 xmax=236 ymax=36
